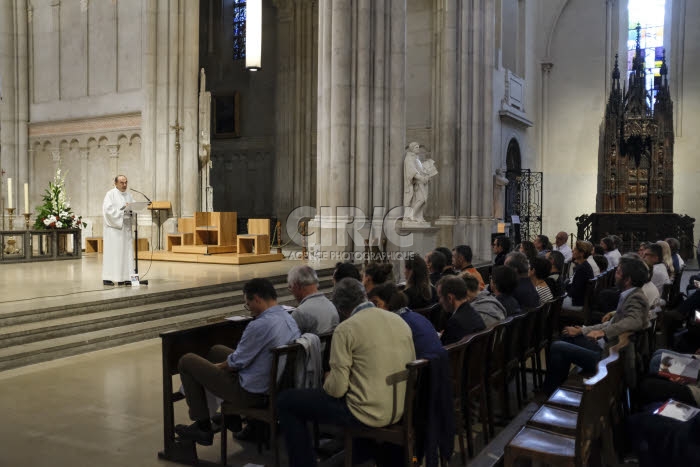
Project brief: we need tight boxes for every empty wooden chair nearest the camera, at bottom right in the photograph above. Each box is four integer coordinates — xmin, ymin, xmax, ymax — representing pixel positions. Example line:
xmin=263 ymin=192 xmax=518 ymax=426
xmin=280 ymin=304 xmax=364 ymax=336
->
xmin=504 ymin=360 xmax=609 ymax=467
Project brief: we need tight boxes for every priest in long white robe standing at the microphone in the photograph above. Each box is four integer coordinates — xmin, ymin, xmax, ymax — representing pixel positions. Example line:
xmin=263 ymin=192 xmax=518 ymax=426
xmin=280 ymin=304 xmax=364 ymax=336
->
xmin=102 ymin=175 xmax=134 ymax=285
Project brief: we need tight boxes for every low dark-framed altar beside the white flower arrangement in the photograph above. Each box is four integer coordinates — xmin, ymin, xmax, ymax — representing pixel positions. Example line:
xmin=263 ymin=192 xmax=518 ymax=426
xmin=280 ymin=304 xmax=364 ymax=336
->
xmin=0 ymin=229 xmax=82 ymax=263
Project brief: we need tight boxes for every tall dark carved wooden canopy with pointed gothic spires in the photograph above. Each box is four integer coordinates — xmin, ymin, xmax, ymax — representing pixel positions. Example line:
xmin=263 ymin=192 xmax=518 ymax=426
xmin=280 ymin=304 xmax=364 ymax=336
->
xmin=596 ymin=26 xmax=673 ymax=213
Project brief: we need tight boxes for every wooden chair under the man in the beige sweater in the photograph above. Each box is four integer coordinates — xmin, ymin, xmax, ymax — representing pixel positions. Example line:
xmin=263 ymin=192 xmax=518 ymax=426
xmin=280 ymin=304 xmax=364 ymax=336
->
xmin=345 ymin=359 xmax=428 ymax=467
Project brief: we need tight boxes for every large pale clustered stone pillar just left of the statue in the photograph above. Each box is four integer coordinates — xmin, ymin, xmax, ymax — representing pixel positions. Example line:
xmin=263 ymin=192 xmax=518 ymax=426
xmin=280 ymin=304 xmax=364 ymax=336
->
xmin=311 ymin=0 xmax=406 ymax=251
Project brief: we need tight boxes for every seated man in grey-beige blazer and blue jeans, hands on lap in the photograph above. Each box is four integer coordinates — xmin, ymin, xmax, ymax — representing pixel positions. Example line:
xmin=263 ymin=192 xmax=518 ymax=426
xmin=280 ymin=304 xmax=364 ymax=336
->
xmin=542 ymin=258 xmax=649 ymax=396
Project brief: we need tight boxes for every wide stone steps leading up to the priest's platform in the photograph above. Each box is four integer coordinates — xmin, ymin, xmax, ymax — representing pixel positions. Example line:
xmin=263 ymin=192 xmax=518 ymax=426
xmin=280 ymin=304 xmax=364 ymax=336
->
xmin=0 ymin=270 xmax=340 ymax=371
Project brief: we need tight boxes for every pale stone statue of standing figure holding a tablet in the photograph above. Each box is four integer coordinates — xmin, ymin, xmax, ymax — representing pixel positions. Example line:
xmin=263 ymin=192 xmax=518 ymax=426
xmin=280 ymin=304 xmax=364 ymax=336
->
xmin=403 ymin=142 xmax=438 ymax=222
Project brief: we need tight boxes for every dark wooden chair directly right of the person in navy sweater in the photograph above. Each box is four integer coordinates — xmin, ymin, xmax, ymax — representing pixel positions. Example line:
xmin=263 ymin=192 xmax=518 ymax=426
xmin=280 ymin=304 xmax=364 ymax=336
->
xmin=445 ymin=330 xmax=491 ymax=465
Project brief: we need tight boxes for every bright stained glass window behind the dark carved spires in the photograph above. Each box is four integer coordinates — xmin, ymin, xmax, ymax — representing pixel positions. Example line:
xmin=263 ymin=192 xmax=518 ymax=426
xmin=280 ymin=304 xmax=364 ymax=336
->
xmin=627 ymin=0 xmax=666 ymax=102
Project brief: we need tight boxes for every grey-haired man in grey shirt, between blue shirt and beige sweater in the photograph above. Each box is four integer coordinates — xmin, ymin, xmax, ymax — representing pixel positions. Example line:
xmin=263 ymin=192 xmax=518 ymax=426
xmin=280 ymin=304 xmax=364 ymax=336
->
xmin=287 ymin=265 xmax=339 ymax=334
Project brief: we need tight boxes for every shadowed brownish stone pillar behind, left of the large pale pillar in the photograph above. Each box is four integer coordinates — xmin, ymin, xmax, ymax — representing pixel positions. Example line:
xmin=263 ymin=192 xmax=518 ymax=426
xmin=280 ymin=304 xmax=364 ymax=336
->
xmin=274 ymin=0 xmax=318 ymax=227
